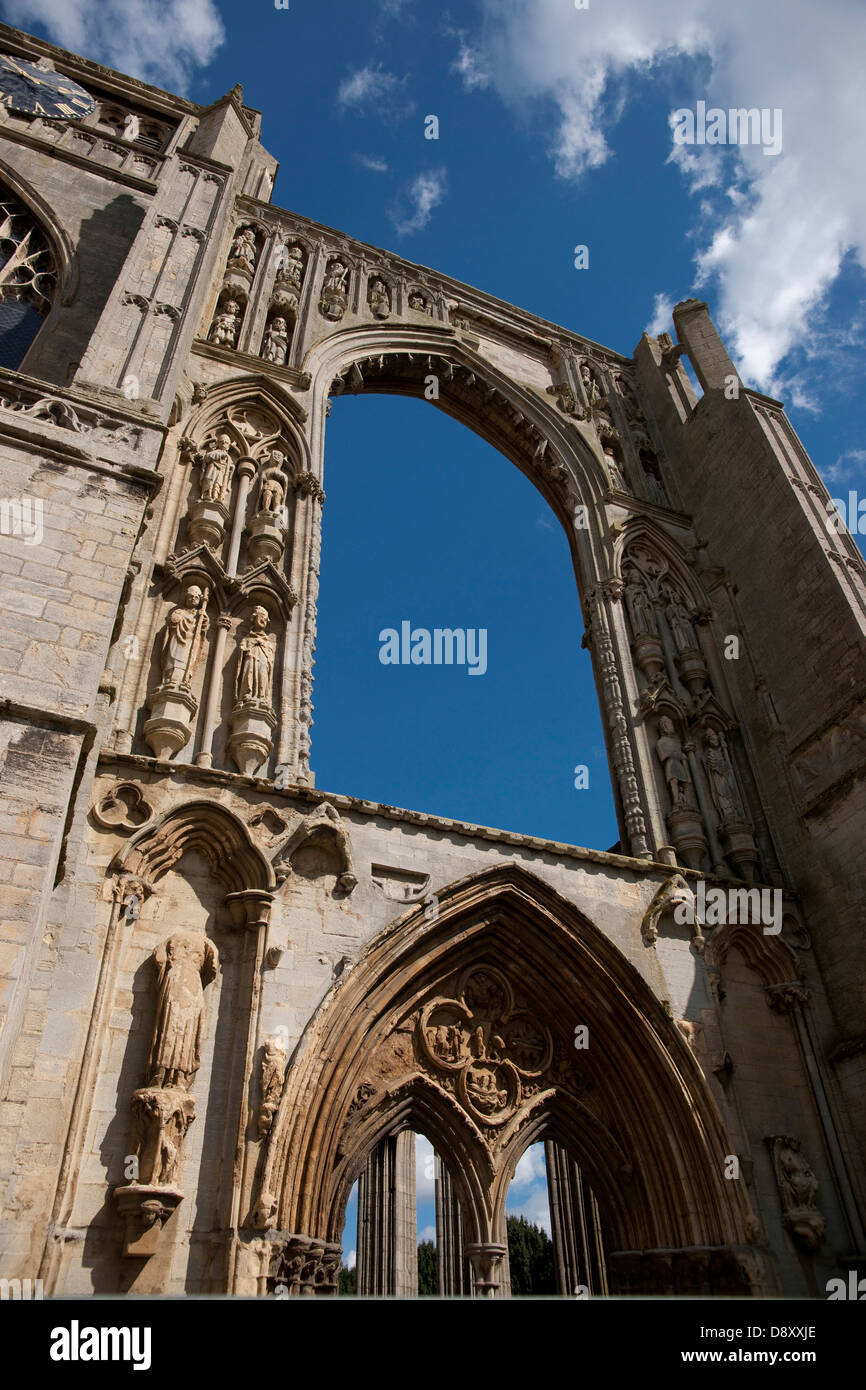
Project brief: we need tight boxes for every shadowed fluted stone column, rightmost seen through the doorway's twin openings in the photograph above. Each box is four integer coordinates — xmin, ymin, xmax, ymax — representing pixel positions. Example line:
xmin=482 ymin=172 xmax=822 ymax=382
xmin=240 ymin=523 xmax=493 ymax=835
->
xmin=545 ymin=1140 xmax=607 ymax=1295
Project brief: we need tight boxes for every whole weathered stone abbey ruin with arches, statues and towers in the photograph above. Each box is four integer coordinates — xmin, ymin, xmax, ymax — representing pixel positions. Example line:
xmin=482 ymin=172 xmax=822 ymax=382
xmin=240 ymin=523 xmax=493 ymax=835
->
xmin=0 ymin=28 xmax=866 ymax=1297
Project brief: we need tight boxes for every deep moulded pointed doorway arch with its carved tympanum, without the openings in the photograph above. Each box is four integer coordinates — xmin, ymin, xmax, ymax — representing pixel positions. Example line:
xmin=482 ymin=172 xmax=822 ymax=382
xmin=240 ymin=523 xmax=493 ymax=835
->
xmin=254 ymin=865 xmax=749 ymax=1278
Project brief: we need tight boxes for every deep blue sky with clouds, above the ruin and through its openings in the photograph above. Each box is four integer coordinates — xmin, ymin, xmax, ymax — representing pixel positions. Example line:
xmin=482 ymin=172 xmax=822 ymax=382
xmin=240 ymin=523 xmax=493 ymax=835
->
xmin=6 ymin=0 xmax=866 ymax=1250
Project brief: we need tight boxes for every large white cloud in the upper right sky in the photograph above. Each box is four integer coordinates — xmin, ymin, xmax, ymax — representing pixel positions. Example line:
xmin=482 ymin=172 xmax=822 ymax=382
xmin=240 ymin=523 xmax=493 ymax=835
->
xmin=480 ymin=0 xmax=866 ymax=392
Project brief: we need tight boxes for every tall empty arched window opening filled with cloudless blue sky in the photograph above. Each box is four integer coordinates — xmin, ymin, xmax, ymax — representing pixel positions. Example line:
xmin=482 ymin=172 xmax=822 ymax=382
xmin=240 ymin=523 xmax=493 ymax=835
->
xmin=313 ymin=395 xmax=619 ymax=849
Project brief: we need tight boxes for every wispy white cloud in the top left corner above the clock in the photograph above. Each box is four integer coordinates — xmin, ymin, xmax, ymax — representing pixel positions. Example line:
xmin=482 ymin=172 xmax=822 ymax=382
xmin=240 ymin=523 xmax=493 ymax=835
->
xmin=3 ymin=0 xmax=225 ymax=93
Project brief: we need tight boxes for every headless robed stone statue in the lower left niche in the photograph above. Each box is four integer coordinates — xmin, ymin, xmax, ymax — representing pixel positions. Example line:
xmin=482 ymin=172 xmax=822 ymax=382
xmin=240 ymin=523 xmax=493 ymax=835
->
xmin=147 ymin=931 xmax=220 ymax=1091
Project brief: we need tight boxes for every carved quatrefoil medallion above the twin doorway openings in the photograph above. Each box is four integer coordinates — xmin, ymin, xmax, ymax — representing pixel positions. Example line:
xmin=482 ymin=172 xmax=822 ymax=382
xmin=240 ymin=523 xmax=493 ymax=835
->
xmin=417 ymin=966 xmax=553 ymax=1126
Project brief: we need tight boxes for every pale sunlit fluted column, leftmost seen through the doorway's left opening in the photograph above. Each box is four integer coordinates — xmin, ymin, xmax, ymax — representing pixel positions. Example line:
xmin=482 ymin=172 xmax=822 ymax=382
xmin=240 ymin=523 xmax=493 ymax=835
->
xmin=357 ymin=1130 xmax=418 ymax=1298
